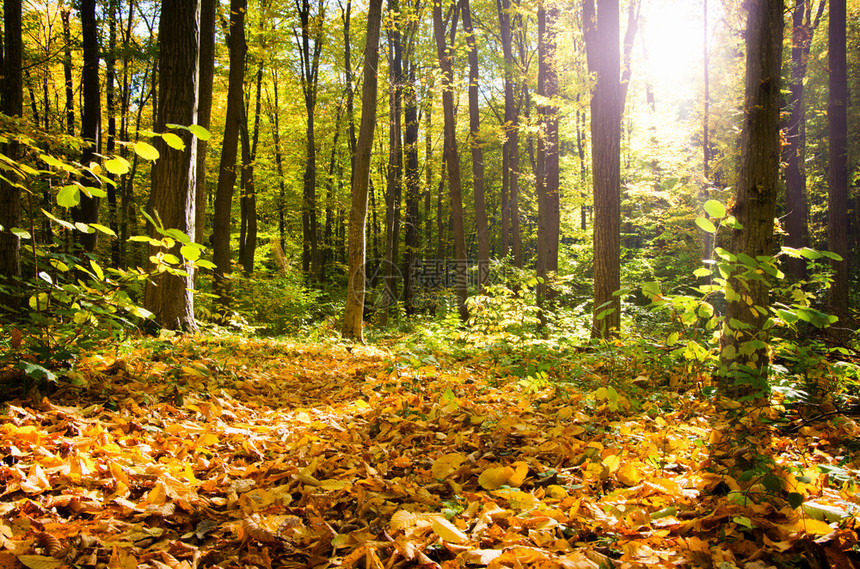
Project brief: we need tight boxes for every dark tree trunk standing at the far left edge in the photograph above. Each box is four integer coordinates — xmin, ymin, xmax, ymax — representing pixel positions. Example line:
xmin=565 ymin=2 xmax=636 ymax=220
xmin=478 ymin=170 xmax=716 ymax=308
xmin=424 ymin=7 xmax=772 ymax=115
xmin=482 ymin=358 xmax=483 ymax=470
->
xmin=0 ymin=0 xmax=24 ymax=311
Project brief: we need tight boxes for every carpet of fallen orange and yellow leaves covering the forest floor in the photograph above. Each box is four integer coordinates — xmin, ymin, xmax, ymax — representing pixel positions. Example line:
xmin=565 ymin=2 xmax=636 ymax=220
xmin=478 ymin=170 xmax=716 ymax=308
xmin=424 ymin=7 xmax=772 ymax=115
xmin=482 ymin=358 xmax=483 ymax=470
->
xmin=0 ymin=338 xmax=860 ymax=569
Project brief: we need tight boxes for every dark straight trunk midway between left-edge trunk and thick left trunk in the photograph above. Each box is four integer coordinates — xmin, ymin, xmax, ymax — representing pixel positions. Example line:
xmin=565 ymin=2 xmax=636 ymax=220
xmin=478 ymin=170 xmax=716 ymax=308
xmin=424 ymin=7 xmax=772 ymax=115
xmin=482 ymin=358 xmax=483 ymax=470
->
xmin=73 ymin=0 xmax=102 ymax=252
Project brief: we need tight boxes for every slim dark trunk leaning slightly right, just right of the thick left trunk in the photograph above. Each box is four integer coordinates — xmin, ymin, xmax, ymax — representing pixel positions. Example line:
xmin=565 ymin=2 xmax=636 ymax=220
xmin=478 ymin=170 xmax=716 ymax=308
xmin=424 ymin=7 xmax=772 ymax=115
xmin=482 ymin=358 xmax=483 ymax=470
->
xmin=212 ymin=0 xmax=248 ymax=311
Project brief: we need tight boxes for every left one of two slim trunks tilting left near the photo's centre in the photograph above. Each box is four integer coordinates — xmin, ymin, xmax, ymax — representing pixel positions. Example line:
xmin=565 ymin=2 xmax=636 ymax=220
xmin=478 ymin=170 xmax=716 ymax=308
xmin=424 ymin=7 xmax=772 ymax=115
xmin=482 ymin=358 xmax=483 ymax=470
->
xmin=433 ymin=3 xmax=469 ymax=321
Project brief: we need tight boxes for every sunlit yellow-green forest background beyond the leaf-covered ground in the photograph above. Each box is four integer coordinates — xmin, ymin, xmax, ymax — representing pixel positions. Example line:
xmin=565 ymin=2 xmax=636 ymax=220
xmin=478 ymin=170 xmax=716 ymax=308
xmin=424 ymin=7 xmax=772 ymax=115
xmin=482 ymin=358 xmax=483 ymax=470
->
xmin=0 ymin=0 xmax=860 ymax=386
